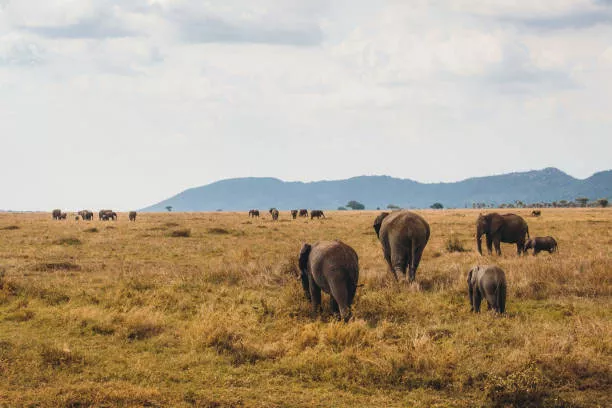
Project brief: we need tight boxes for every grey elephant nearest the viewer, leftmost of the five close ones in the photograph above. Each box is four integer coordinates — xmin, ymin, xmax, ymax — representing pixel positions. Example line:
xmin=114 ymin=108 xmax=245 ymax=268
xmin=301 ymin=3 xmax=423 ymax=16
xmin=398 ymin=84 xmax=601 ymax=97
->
xmin=299 ymin=241 xmax=359 ymax=322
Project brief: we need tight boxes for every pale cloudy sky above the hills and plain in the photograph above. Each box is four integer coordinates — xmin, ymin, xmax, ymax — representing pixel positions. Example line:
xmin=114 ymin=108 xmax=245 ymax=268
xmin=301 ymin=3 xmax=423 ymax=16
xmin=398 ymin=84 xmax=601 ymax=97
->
xmin=0 ymin=0 xmax=612 ymax=210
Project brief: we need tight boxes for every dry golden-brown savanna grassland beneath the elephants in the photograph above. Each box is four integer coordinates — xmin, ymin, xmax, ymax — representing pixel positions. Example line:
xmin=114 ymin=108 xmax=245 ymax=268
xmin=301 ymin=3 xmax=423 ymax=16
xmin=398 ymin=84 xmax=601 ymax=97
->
xmin=0 ymin=209 xmax=612 ymax=407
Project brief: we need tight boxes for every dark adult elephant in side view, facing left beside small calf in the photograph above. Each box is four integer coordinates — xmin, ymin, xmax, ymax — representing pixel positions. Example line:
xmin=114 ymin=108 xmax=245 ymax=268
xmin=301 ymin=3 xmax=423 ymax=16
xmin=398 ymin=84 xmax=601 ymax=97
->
xmin=476 ymin=213 xmax=529 ymax=255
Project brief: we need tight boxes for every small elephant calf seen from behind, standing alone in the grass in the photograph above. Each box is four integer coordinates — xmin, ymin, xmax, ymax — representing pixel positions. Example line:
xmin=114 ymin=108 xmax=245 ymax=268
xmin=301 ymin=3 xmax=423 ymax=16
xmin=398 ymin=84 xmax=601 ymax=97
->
xmin=468 ymin=265 xmax=506 ymax=313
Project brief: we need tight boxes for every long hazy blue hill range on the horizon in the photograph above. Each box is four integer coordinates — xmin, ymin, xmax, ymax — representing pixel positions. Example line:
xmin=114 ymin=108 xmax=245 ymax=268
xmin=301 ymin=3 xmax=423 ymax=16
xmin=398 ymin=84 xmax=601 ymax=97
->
xmin=141 ymin=168 xmax=612 ymax=211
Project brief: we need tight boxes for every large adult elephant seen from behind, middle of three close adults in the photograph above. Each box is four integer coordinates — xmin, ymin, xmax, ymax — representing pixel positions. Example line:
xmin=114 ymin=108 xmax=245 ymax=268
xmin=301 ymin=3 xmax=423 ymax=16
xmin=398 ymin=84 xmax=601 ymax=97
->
xmin=374 ymin=210 xmax=430 ymax=282
